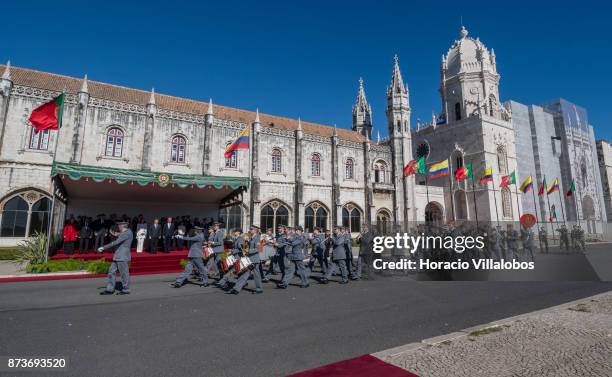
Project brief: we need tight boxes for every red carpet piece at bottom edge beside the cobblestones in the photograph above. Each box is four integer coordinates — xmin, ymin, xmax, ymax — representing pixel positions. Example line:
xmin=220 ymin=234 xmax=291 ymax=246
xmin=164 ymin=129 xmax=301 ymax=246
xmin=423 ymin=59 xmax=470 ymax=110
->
xmin=287 ymin=355 xmax=418 ymax=377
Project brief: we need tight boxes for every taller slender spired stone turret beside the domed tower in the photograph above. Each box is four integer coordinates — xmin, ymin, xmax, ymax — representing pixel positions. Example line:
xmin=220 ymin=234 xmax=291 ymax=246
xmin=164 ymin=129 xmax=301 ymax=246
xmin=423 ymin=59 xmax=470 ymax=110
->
xmin=388 ymin=55 xmax=416 ymax=226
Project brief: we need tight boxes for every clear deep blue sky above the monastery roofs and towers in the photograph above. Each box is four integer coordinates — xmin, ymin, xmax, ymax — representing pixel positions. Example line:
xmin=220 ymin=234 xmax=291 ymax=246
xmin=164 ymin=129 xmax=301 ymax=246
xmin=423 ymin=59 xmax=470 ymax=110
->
xmin=0 ymin=0 xmax=612 ymax=139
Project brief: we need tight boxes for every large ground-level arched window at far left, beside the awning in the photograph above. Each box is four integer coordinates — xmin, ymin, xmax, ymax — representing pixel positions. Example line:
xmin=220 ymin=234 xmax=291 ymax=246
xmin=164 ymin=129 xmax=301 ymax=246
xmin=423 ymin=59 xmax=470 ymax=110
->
xmin=0 ymin=191 xmax=51 ymax=237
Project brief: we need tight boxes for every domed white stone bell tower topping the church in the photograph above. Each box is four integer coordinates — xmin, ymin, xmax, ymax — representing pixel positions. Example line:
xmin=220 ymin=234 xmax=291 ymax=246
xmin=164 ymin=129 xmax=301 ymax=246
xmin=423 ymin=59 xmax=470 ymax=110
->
xmin=440 ymin=26 xmax=499 ymax=125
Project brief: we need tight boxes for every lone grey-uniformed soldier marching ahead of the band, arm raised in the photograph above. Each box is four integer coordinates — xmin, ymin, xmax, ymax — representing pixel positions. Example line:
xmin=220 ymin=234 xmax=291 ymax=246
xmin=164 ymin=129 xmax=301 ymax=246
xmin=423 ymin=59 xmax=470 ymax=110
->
xmin=98 ymin=222 xmax=134 ymax=295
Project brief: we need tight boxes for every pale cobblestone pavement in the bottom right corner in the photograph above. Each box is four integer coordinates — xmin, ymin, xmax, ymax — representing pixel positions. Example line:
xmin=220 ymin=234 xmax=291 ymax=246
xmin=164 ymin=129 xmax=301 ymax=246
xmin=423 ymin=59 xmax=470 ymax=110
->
xmin=379 ymin=291 xmax=612 ymax=377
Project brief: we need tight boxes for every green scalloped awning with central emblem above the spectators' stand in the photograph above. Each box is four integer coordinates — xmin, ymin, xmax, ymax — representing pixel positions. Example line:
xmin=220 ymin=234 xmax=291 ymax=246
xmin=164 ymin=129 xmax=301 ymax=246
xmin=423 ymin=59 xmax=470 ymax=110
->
xmin=51 ymin=162 xmax=249 ymax=189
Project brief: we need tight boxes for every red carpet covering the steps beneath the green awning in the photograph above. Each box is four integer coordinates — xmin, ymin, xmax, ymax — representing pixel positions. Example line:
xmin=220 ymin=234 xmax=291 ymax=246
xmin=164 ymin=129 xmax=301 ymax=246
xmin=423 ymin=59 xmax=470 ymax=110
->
xmin=51 ymin=249 xmax=187 ymax=274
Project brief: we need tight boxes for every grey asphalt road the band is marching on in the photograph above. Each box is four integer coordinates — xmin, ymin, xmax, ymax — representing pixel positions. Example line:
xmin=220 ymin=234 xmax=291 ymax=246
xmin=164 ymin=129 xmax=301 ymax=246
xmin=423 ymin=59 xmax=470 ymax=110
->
xmin=0 ymin=247 xmax=612 ymax=377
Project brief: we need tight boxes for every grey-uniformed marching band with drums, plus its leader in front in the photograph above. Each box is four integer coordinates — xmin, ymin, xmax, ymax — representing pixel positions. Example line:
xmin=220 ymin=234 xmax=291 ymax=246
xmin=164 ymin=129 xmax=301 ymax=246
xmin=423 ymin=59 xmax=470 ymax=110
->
xmin=98 ymin=222 xmax=374 ymax=294
